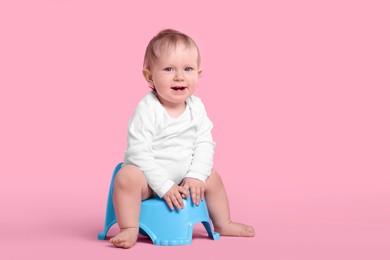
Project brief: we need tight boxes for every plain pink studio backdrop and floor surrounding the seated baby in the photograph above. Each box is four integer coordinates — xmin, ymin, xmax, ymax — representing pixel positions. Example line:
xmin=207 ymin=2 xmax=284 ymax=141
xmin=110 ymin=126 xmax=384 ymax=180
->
xmin=0 ymin=0 xmax=390 ymax=260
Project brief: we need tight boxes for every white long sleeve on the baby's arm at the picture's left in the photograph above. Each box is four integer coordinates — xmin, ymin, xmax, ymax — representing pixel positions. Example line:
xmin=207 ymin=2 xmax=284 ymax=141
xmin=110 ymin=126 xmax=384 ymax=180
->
xmin=124 ymin=103 xmax=174 ymax=197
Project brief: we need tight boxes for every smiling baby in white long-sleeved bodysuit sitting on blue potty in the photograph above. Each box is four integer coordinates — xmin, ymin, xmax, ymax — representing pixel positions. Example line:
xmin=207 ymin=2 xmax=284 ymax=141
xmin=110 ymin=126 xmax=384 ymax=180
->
xmin=110 ymin=29 xmax=255 ymax=248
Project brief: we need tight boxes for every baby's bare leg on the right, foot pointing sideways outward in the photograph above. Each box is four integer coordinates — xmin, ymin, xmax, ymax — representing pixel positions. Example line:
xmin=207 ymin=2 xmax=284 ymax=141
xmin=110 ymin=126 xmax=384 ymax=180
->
xmin=205 ymin=169 xmax=255 ymax=237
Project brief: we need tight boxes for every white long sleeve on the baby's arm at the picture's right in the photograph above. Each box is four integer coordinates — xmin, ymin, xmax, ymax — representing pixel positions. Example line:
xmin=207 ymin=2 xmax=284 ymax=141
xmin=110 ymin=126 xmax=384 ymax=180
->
xmin=186 ymin=98 xmax=215 ymax=182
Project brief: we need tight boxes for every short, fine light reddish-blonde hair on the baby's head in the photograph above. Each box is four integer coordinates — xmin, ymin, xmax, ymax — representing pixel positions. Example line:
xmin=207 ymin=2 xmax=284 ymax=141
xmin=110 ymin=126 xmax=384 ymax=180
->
xmin=144 ymin=29 xmax=200 ymax=70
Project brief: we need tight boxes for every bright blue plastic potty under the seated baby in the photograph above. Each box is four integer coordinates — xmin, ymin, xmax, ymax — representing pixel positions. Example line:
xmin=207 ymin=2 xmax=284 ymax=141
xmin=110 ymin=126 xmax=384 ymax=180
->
xmin=98 ymin=163 xmax=219 ymax=246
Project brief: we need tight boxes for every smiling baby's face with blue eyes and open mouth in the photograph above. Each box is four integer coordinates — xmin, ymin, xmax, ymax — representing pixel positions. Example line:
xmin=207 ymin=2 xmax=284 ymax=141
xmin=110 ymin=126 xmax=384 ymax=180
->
xmin=144 ymin=44 xmax=201 ymax=107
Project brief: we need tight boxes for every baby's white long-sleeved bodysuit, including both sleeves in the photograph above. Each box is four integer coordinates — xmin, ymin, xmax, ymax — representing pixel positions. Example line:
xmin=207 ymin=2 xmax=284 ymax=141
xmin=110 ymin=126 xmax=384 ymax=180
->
xmin=124 ymin=92 xmax=215 ymax=197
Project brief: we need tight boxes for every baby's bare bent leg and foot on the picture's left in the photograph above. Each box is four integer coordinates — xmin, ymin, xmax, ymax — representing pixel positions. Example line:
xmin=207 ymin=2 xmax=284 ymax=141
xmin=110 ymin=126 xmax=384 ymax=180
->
xmin=110 ymin=165 xmax=153 ymax=248
